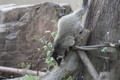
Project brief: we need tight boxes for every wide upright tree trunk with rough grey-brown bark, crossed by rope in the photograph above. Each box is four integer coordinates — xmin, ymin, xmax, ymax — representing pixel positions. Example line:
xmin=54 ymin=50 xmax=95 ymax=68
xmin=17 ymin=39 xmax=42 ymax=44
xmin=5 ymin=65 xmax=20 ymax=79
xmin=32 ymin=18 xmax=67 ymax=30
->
xmin=82 ymin=0 xmax=120 ymax=80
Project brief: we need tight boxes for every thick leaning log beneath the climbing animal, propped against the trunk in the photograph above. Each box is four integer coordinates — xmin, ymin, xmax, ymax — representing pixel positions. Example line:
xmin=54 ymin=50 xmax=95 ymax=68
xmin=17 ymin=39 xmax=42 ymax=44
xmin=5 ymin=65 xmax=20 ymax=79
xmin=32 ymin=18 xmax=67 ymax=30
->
xmin=37 ymin=29 xmax=90 ymax=80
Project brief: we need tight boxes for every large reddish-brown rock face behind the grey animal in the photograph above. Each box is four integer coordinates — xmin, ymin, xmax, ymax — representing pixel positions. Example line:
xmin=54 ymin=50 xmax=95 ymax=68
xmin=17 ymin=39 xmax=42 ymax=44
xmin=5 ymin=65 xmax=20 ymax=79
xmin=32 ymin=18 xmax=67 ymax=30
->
xmin=0 ymin=2 xmax=71 ymax=70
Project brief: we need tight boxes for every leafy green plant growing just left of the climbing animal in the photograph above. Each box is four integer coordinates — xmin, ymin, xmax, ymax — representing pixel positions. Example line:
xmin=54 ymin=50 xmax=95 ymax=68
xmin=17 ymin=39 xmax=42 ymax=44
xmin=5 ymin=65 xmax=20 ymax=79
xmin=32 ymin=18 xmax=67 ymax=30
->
xmin=38 ymin=31 xmax=57 ymax=72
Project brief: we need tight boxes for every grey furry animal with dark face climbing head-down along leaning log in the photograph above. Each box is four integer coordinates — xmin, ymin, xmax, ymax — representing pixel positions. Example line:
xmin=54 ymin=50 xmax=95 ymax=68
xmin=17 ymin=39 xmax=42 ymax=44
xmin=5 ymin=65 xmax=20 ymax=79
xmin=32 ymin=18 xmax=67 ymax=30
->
xmin=52 ymin=0 xmax=88 ymax=66
